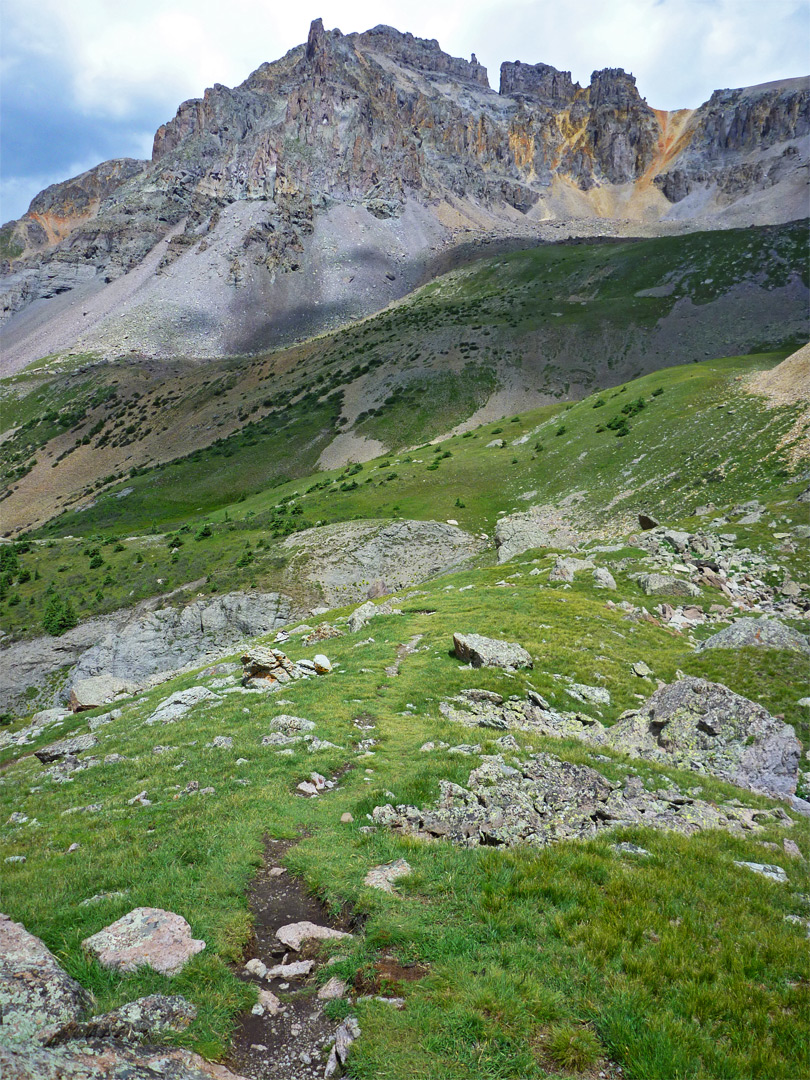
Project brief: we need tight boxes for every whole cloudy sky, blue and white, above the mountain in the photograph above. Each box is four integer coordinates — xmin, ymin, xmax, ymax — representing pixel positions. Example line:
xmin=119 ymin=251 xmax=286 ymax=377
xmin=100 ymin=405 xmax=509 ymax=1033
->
xmin=0 ymin=0 xmax=810 ymax=221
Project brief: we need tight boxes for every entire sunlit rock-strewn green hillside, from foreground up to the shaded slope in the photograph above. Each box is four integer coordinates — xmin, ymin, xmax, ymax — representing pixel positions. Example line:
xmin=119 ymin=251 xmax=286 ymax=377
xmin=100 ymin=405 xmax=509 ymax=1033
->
xmin=0 ymin=347 xmax=810 ymax=1080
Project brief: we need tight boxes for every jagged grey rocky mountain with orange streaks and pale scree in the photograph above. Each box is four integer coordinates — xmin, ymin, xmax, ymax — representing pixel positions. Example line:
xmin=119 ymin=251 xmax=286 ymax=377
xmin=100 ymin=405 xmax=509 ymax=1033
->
xmin=0 ymin=19 xmax=810 ymax=364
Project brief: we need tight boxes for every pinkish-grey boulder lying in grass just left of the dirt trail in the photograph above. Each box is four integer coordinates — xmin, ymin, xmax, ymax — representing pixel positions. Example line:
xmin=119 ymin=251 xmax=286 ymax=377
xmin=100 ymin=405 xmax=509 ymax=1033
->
xmin=82 ymin=907 xmax=205 ymax=975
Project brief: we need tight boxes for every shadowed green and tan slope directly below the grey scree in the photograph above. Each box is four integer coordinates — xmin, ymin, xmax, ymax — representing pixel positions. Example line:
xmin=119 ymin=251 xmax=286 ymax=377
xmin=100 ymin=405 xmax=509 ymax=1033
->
xmin=0 ymin=225 xmax=808 ymax=531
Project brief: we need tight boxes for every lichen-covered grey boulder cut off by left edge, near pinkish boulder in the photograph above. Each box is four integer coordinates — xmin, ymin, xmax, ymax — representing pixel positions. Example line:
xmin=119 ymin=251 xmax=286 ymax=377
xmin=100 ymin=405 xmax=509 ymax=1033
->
xmin=0 ymin=915 xmax=91 ymax=1045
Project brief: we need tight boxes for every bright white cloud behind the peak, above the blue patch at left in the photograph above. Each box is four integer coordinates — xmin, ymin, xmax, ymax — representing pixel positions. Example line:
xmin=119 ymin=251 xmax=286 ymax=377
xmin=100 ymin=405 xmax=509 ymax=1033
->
xmin=4 ymin=0 xmax=808 ymax=117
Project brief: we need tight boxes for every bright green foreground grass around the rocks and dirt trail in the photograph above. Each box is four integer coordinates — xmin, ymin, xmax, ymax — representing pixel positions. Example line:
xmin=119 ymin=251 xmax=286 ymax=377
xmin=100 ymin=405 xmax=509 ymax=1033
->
xmin=0 ymin=552 xmax=810 ymax=1080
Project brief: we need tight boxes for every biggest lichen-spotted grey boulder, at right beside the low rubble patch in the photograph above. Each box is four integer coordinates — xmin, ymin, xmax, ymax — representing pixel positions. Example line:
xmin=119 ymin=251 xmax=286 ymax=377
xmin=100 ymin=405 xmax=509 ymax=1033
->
xmin=607 ymin=678 xmax=801 ymax=797
